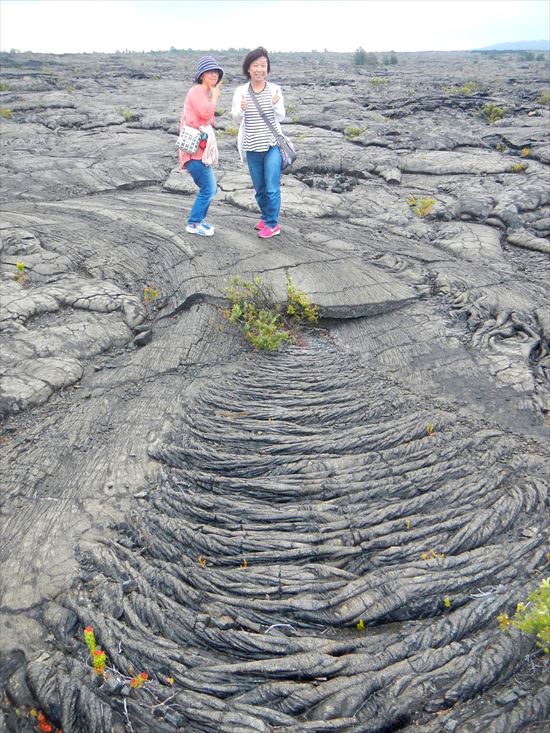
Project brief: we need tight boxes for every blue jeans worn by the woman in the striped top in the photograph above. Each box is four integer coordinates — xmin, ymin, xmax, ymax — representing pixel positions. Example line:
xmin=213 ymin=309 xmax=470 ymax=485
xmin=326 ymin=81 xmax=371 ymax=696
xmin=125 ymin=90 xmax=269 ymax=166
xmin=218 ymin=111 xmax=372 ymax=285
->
xmin=246 ymin=145 xmax=282 ymax=229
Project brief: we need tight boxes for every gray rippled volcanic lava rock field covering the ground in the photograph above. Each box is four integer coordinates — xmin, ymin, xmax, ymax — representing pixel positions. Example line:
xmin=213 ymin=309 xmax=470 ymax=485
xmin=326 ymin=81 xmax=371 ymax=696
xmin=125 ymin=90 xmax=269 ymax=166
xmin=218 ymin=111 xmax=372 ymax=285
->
xmin=0 ymin=47 xmax=550 ymax=733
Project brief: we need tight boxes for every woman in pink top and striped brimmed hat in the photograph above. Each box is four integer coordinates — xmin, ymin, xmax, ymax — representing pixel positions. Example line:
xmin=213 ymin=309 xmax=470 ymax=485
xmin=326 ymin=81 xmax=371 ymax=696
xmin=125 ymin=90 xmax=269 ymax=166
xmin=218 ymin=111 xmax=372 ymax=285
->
xmin=179 ymin=56 xmax=223 ymax=237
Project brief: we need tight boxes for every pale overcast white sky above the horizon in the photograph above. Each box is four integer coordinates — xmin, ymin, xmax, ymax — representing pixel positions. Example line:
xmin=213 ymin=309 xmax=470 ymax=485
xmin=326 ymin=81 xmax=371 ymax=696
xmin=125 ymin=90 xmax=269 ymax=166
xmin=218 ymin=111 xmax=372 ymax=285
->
xmin=0 ymin=0 xmax=550 ymax=53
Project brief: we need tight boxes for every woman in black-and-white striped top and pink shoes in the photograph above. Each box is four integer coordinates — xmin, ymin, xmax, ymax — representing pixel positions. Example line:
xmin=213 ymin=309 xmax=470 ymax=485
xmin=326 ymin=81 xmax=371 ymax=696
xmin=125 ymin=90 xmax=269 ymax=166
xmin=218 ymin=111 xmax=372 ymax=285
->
xmin=231 ymin=46 xmax=285 ymax=239
